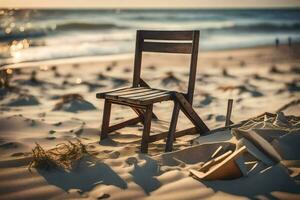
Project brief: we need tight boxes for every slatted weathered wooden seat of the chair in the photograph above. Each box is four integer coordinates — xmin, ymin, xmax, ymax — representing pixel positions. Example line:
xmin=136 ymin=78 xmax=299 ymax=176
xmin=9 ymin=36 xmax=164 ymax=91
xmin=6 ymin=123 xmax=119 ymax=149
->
xmin=96 ymin=87 xmax=172 ymax=105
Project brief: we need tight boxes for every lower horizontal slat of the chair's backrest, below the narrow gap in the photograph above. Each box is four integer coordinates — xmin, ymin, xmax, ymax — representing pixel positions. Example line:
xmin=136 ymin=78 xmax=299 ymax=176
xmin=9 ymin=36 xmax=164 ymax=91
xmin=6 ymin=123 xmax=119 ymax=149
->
xmin=142 ymin=42 xmax=192 ymax=54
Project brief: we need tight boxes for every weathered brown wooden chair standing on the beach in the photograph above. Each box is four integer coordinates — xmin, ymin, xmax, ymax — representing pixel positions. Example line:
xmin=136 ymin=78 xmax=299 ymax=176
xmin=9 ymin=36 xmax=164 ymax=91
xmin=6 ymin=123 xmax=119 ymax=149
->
xmin=96 ymin=30 xmax=209 ymax=153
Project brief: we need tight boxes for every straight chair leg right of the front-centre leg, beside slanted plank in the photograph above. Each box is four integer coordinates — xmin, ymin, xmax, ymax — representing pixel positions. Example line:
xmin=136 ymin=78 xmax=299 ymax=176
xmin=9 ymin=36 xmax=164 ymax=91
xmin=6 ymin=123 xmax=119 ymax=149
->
xmin=165 ymin=101 xmax=180 ymax=152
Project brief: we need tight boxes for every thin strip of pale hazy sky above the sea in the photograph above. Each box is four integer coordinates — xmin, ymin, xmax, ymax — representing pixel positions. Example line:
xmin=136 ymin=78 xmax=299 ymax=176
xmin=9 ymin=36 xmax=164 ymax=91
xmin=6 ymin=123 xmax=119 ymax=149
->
xmin=0 ymin=0 xmax=300 ymax=9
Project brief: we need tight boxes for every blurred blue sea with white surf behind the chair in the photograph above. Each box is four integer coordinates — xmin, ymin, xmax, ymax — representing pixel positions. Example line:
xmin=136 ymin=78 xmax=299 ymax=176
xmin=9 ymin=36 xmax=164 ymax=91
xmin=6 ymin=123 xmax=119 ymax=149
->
xmin=0 ymin=9 xmax=300 ymax=64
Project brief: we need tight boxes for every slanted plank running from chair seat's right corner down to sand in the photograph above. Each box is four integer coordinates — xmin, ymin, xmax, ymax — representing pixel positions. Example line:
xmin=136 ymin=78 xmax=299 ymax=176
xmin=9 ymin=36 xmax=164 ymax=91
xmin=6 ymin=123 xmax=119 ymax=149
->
xmin=174 ymin=92 xmax=209 ymax=135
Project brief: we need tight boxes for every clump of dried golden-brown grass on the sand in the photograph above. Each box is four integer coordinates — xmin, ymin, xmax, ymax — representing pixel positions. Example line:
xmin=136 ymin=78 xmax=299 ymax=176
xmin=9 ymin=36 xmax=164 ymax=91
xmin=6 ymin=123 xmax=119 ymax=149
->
xmin=29 ymin=140 xmax=90 ymax=171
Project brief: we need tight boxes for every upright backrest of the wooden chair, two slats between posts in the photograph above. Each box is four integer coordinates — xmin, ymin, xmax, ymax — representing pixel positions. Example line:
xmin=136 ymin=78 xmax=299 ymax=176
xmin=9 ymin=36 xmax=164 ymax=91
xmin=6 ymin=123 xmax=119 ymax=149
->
xmin=133 ymin=30 xmax=200 ymax=103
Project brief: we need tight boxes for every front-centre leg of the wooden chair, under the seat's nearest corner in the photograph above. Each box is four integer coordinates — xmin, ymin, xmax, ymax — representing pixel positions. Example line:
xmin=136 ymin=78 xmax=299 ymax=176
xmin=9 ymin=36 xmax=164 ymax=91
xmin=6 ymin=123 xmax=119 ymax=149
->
xmin=141 ymin=105 xmax=153 ymax=153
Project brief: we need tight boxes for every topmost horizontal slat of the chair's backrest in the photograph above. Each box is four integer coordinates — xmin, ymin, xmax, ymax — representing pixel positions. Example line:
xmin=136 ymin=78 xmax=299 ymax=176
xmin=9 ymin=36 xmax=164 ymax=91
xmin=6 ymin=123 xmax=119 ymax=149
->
xmin=141 ymin=30 xmax=193 ymax=40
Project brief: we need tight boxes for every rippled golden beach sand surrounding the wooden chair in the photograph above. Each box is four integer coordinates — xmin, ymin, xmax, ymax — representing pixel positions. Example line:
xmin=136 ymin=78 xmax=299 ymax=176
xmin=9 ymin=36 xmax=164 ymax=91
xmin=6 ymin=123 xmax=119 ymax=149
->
xmin=0 ymin=45 xmax=300 ymax=199
